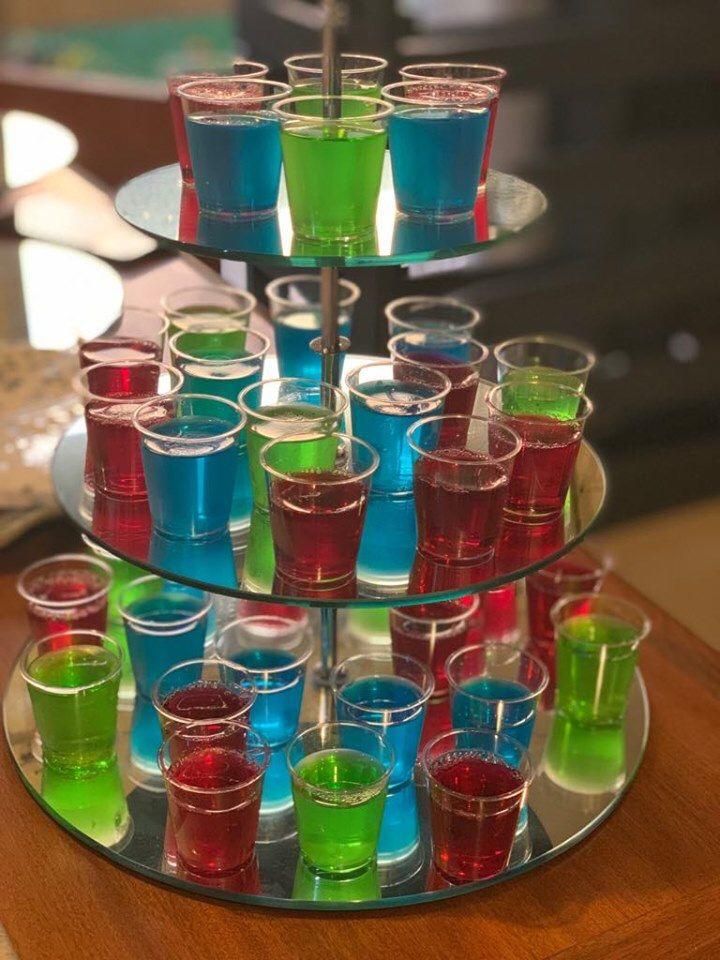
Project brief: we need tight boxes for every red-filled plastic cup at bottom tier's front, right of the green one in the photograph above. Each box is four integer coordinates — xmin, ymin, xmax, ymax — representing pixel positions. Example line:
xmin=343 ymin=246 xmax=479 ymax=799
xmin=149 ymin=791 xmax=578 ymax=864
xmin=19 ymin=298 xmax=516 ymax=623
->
xmin=422 ymin=730 xmax=533 ymax=883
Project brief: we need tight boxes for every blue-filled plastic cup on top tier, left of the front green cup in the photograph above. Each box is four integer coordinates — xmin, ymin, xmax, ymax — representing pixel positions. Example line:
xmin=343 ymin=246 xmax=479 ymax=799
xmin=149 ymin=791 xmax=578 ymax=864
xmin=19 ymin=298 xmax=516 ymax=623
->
xmin=177 ymin=77 xmax=292 ymax=218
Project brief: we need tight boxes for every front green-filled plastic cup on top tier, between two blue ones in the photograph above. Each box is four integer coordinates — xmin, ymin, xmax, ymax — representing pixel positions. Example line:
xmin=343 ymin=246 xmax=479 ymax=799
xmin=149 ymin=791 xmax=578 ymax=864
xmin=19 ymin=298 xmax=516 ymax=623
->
xmin=273 ymin=96 xmax=392 ymax=241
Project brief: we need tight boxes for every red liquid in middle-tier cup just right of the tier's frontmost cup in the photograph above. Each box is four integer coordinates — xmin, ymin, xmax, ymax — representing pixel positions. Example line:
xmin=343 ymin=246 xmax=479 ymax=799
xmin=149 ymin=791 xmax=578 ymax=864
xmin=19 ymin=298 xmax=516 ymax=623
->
xmin=414 ymin=447 xmax=508 ymax=563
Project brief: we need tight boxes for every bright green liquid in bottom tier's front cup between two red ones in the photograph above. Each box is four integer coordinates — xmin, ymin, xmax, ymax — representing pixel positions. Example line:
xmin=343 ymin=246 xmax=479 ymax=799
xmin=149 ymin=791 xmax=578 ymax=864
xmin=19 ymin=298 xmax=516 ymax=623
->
xmin=293 ymin=748 xmax=385 ymax=875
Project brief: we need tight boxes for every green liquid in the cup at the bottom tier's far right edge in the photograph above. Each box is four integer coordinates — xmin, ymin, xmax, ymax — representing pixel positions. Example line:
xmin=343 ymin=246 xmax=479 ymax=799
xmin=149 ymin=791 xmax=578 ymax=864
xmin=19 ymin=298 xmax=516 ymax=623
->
xmin=556 ymin=614 xmax=638 ymax=726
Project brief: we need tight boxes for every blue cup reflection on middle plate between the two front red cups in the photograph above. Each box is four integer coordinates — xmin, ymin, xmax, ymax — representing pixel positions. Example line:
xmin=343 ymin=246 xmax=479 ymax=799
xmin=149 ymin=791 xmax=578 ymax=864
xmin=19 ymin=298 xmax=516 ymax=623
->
xmin=357 ymin=490 xmax=417 ymax=585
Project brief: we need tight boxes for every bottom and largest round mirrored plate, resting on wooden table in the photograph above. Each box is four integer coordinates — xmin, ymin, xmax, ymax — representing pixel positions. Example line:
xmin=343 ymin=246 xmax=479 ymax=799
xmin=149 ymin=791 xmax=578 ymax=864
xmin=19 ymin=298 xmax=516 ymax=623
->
xmin=4 ymin=635 xmax=649 ymax=910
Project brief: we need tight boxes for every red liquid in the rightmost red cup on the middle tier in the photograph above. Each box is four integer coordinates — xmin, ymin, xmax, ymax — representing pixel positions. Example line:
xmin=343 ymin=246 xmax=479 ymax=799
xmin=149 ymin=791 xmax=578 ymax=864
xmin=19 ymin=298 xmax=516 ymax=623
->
xmin=506 ymin=414 xmax=582 ymax=517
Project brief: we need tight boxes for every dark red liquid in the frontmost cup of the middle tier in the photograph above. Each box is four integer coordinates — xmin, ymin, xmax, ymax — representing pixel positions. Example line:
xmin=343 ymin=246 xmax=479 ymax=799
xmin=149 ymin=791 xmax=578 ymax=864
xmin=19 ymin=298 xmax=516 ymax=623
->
xmin=270 ymin=471 xmax=368 ymax=587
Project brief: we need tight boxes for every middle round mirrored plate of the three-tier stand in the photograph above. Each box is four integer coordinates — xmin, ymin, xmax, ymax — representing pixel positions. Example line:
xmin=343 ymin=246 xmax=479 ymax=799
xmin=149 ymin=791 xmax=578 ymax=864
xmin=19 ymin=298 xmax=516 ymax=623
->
xmin=52 ymin=354 xmax=606 ymax=607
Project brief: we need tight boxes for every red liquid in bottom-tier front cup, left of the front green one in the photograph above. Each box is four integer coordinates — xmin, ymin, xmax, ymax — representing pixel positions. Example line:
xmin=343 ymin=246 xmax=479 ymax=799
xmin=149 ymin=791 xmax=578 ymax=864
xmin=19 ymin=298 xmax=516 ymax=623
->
xmin=168 ymin=747 xmax=262 ymax=875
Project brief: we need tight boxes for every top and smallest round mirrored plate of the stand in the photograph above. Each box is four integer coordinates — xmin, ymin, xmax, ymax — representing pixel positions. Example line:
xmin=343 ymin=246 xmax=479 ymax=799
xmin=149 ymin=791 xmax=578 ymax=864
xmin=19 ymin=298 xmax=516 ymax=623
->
xmin=115 ymin=156 xmax=547 ymax=267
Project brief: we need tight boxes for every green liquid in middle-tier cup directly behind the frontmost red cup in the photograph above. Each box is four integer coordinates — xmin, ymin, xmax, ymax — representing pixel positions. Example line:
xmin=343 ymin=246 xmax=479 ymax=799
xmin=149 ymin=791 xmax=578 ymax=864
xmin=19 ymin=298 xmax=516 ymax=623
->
xmin=247 ymin=403 xmax=338 ymax=510
